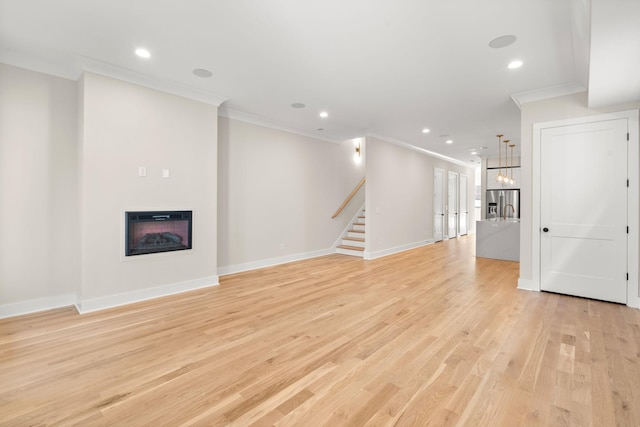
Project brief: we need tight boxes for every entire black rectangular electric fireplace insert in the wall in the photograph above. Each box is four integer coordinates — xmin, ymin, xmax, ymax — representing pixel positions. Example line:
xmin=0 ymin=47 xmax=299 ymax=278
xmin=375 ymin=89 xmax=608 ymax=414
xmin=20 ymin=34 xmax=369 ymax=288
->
xmin=125 ymin=211 xmax=191 ymax=256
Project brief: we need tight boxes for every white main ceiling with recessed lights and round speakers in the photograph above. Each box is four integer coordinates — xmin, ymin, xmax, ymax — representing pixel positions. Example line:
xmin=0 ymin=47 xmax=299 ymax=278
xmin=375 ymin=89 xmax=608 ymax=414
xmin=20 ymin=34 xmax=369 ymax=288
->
xmin=0 ymin=0 xmax=640 ymax=164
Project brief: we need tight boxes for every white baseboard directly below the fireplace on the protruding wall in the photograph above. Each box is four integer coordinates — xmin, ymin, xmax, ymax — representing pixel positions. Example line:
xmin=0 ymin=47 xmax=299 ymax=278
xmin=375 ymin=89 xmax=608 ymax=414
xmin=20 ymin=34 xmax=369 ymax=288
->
xmin=76 ymin=276 xmax=218 ymax=314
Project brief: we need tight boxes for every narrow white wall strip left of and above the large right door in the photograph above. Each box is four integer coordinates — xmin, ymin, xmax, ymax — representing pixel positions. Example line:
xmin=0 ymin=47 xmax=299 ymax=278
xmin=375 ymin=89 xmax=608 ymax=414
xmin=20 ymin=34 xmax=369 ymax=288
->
xmin=520 ymin=92 xmax=640 ymax=288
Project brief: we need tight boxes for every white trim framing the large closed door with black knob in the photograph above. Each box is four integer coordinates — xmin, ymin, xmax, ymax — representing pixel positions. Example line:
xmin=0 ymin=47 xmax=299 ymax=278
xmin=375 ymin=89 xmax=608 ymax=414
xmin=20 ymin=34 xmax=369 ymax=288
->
xmin=521 ymin=110 xmax=640 ymax=308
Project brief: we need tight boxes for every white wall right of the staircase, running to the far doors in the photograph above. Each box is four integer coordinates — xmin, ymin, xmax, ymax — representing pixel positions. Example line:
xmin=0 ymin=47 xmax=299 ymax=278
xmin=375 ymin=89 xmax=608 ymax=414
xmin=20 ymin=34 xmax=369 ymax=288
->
xmin=365 ymin=137 xmax=475 ymax=258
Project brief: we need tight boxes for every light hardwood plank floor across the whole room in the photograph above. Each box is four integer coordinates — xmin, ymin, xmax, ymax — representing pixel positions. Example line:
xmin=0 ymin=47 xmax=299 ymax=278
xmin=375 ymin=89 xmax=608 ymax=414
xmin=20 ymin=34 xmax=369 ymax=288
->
xmin=0 ymin=236 xmax=640 ymax=426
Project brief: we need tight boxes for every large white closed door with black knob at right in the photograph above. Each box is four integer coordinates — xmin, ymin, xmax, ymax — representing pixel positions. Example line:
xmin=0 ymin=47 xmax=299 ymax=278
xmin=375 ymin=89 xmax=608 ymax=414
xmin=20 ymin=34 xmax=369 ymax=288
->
xmin=540 ymin=119 xmax=628 ymax=303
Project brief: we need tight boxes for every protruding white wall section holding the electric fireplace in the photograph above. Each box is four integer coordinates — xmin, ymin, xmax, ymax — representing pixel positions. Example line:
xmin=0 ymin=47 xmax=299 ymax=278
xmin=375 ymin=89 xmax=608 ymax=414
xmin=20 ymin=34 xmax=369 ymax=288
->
xmin=78 ymin=73 xmax=217 ymax=311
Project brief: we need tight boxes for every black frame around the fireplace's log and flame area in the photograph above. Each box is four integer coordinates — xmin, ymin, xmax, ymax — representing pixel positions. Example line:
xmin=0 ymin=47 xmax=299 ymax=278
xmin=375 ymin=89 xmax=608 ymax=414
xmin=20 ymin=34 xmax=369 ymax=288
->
xmin=124 ymin=211 xmax=193 ymax=256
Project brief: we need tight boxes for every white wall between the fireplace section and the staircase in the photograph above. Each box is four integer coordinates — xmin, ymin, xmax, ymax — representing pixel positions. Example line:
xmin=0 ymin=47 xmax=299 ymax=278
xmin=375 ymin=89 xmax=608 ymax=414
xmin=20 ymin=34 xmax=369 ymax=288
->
xmin=218 ymin=117 xmax=364 ymax=274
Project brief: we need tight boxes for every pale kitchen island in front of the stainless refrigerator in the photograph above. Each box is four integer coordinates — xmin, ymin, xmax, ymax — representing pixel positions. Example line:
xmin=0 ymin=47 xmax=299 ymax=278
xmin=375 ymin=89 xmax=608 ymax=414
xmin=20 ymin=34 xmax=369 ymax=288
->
xmin=476 ymin=218 xmax=520 ymax=261
